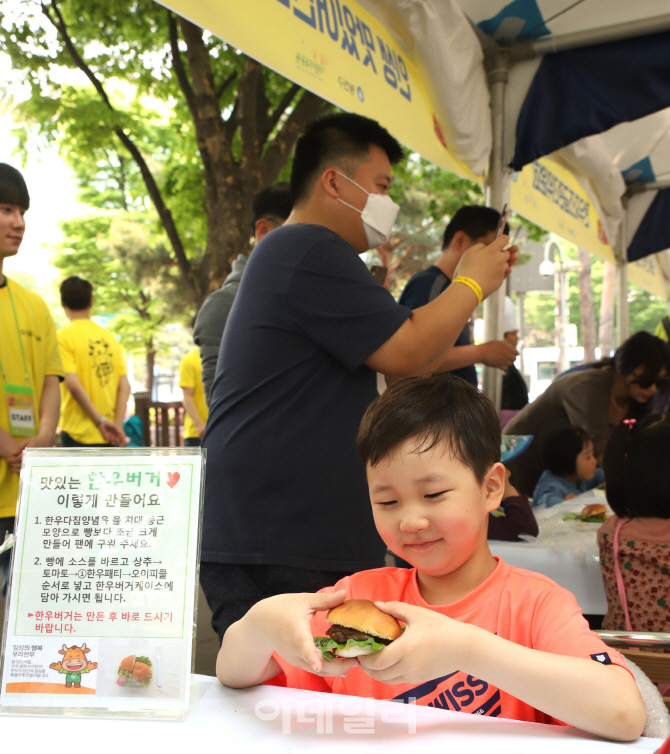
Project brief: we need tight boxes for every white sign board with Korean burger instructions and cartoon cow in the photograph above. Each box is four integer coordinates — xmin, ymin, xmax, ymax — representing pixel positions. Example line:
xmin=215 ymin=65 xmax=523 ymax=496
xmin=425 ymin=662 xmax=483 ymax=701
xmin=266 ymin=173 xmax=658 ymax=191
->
xmin=0 ymin=448 xmax=204 ymax=717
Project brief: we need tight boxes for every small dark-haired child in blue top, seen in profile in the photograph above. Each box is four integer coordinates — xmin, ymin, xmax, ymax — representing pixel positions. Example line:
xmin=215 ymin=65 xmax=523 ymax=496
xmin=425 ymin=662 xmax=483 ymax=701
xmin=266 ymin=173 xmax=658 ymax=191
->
xmin=533 ymin=427 xmax=605 ymax=508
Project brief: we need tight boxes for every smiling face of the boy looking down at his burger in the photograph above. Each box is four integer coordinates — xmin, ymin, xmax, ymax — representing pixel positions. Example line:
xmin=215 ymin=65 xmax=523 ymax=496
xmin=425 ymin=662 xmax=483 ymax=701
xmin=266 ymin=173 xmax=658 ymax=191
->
xmin=367 ymin=440 xmax=505 ymax=576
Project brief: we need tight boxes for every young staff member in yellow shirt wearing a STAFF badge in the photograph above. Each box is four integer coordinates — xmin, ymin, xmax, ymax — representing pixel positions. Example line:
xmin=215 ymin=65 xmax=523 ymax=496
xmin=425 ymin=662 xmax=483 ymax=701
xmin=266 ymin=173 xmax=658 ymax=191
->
xmin=0 ymin=163 xmax=63 ymax=597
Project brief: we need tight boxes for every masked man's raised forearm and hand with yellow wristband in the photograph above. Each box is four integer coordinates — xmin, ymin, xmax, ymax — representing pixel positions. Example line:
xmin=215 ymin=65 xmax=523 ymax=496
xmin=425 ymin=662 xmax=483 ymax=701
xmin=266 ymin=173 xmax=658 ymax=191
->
xmin=365 ymin=236 xmax=516 ymax=378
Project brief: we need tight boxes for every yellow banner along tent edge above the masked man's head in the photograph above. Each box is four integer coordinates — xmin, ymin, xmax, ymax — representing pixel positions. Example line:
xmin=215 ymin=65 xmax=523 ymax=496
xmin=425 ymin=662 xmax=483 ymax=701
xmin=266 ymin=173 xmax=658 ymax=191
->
xmin=161 ymin=0 xmax=475 ymax=180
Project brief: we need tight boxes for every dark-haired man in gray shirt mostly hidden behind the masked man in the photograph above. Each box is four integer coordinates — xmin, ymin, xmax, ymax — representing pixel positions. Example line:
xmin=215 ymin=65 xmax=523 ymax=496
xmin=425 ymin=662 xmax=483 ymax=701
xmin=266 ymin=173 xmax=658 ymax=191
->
xmin=193 ymin=183 xmax=293 ymax=406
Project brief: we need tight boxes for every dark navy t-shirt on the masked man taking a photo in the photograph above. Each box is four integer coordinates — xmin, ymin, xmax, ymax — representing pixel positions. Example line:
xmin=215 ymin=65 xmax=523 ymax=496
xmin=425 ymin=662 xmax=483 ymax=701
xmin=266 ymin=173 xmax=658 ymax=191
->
xmin=202 ymin=225 xmax=410 ymax=570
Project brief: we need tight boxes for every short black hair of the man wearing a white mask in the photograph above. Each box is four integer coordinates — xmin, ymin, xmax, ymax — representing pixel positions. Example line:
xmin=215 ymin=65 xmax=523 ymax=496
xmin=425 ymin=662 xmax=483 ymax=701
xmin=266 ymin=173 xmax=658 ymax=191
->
xmin=291 ymin=113 xmax=403 ymax=205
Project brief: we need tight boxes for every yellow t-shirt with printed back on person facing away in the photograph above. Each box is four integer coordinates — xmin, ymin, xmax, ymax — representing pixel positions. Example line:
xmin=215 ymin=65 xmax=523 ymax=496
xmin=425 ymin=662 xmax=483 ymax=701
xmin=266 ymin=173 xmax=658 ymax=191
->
xmin=58 ymin=319 xmax=126 ymax=445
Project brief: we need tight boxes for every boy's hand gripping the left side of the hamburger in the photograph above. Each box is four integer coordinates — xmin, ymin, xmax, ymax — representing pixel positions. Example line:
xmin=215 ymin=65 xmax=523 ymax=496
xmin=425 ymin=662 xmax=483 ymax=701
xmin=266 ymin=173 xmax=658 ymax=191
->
xmin=248 ymin=590 xmax=358 ymax=676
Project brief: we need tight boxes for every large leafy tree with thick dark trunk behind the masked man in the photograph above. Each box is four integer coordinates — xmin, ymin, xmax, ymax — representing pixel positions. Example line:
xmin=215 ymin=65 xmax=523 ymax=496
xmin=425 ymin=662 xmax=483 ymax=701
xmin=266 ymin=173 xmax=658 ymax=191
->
xmin=0 ymin=0 xmax=330 ymax=306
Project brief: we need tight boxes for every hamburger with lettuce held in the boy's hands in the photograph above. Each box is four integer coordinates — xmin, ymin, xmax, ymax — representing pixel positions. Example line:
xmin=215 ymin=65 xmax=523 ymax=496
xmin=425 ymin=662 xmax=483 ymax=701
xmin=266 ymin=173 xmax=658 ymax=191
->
xmin=314 ymin=600 xmax=402 ymax=662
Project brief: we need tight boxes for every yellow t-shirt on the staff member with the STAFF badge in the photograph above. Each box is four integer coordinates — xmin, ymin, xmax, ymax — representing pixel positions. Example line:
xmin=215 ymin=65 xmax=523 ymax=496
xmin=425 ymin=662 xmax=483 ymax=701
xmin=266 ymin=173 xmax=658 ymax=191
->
xmin=0 ymin=280 xmax=63 ymax=518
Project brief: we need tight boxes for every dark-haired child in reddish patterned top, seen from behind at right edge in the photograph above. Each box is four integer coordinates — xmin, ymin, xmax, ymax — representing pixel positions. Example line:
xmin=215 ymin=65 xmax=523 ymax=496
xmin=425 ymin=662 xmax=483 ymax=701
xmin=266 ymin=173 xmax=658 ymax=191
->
xmin=598 ymin=414 xmax=670 ymax=631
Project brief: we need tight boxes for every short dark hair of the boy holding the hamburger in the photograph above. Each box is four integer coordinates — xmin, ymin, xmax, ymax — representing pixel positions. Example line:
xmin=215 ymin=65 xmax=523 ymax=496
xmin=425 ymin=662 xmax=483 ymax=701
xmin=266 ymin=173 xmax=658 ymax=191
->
xmin=358 ymin=373 xmax=501 ymax=484
